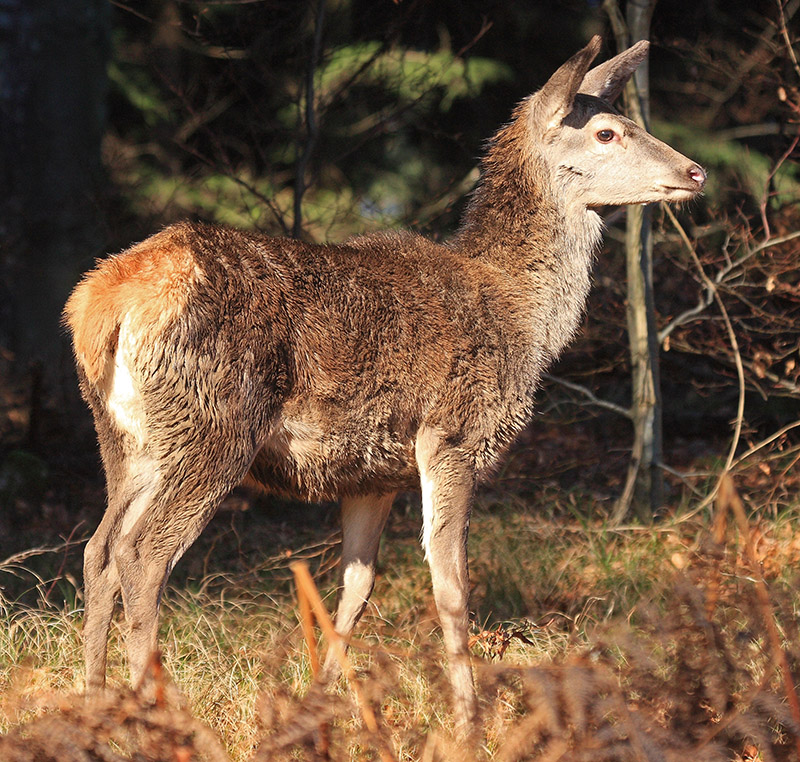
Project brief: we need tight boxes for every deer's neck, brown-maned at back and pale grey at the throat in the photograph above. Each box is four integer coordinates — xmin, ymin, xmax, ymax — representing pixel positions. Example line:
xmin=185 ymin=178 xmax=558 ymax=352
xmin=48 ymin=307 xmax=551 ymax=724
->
xmin=453 ymin=123 xmax=602 ymax=358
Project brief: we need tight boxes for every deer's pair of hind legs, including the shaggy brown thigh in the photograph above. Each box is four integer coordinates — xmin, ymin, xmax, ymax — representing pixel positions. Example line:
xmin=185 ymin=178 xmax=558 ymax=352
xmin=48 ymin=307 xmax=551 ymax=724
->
xmin=85 ymin=338 xmax=273 ymax=687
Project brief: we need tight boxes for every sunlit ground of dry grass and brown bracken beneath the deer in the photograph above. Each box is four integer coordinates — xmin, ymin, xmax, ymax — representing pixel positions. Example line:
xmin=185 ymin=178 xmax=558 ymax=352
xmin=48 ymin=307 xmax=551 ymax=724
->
xmin=0 ymin=484 xmax=800 ymax=762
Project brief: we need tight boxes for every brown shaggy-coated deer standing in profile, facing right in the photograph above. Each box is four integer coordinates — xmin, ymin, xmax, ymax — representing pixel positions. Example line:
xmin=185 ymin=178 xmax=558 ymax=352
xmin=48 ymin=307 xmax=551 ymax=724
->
xmin=64 ymin=36 xmax=706 ymax=727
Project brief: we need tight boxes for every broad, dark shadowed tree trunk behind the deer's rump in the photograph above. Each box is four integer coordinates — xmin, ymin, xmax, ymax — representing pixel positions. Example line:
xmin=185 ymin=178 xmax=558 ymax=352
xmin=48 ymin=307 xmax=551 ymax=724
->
xmin=0 ymin=0 xmax=110 ymax=368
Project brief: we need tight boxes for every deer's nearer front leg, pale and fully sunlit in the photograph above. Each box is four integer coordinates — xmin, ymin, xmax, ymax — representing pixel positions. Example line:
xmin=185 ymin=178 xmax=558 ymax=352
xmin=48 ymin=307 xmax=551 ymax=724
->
xmin=416 ymin=428 xmax=476 ymax=734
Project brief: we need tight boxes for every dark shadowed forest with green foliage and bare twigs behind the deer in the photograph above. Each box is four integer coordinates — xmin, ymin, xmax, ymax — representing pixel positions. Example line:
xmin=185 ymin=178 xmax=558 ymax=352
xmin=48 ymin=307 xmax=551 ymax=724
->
xmin=0 ymin=0 xmax=800 ymax=554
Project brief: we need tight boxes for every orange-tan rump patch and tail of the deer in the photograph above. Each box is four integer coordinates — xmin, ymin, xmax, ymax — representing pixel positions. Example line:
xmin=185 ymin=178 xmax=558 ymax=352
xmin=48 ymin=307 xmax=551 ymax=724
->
xmin=64 ymin=226 xmax=202 ymax=386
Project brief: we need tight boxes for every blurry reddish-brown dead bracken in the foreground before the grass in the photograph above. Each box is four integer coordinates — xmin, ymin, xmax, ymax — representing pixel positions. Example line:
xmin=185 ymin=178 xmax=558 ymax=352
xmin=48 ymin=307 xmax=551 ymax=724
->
xmin=0 ymin=482 xmax=800 ymax=762
